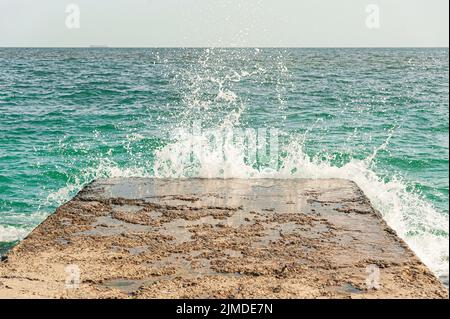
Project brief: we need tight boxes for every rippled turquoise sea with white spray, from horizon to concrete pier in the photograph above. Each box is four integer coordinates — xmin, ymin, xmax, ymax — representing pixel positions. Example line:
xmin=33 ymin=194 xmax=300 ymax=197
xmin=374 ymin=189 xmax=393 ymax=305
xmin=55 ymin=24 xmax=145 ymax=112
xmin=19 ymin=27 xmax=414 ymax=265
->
xmin=0 ymin=48 xmax=449 ymax=281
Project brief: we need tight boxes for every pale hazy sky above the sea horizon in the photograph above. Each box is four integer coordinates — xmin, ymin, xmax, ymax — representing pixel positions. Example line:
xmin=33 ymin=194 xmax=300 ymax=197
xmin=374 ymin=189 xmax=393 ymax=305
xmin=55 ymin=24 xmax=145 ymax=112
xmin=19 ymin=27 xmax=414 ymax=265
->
xmin=0 ymin=0 xmax=449 ymax=47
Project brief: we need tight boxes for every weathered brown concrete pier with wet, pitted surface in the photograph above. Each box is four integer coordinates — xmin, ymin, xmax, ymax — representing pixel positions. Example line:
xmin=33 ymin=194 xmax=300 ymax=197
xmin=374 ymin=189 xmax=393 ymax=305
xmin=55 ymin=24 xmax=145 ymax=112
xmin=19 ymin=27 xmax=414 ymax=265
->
xmin=0 ymin=179 xmax=448 ymax=298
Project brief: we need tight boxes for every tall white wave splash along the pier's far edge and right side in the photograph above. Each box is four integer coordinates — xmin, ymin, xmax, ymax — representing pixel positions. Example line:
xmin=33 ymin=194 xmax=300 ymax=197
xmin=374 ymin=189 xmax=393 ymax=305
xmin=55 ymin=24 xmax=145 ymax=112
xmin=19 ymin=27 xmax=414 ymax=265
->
xmin=153 ymin=50 xmax=449 ymax=277
